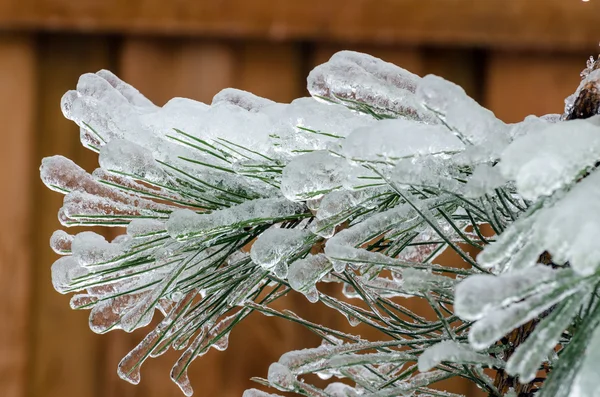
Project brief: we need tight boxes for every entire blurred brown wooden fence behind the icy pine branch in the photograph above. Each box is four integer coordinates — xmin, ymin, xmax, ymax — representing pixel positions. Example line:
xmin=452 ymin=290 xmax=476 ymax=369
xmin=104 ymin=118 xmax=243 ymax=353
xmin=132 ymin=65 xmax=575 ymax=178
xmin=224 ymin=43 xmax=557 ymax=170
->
xmin=0 ymin=0 xmax=600 ymax=397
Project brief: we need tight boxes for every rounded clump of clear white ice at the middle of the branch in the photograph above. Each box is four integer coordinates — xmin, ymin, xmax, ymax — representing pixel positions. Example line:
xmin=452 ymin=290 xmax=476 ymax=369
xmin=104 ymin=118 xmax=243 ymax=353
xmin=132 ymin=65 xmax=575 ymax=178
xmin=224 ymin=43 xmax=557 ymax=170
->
xmin=281 ymin=151 xmax=347 ymax=201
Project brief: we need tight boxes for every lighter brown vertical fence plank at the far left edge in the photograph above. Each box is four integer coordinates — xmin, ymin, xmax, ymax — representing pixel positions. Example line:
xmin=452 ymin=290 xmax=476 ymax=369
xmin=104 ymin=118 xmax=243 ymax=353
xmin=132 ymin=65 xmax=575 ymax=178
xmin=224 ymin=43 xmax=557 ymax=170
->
xmin=0 ymin=34 xmax=36 ymax=397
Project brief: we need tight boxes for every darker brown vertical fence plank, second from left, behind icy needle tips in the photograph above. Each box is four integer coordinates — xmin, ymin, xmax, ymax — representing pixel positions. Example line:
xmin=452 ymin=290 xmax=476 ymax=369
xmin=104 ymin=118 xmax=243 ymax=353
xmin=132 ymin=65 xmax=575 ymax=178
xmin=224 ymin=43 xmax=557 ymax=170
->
xmin=30 ymin=36 xmax=116 ymax=397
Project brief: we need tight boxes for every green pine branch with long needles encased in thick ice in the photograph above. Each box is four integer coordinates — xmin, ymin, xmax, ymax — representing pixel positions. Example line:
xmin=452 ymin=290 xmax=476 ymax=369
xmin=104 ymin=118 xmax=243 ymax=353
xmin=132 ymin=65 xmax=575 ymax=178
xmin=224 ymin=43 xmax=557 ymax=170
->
xmin=41 ymin=52 xmax=600 ymax=397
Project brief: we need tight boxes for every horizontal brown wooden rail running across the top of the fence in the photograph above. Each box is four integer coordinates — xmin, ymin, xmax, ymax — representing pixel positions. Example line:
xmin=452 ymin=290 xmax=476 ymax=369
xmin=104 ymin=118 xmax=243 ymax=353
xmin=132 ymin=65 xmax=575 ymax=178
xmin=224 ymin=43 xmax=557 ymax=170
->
xmin=0 ymin=0 xmax=600 ymax=50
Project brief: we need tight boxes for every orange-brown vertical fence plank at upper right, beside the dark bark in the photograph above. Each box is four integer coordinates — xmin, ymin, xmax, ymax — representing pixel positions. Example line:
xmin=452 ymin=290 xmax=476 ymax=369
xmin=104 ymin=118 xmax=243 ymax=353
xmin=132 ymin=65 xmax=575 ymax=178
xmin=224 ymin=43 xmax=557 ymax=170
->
xmin=485 ymin=52 xmax=587 ymax=122
